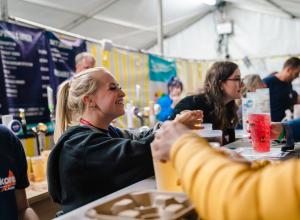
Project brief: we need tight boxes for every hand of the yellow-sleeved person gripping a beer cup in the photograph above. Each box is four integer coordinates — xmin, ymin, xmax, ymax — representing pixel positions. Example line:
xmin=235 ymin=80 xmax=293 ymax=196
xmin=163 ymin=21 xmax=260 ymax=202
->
xmin=151 ymin=121 xmax=190 ymax=162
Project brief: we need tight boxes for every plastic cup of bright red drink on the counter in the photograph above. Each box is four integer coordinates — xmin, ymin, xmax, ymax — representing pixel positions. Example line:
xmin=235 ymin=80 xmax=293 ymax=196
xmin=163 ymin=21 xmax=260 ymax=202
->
xmin=248 ymin=113 xmax=271 ymax=152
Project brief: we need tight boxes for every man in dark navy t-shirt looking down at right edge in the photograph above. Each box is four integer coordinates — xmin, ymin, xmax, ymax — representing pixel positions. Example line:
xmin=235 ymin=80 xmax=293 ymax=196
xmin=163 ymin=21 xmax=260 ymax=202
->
xmin=263 ymin=57 xmax=300 ymax=122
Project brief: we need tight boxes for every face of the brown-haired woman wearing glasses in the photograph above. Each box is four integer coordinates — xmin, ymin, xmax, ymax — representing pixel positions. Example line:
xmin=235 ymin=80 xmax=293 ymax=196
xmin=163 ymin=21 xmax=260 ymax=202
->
xmin=221 ymin=68 xmax=242 ymax=101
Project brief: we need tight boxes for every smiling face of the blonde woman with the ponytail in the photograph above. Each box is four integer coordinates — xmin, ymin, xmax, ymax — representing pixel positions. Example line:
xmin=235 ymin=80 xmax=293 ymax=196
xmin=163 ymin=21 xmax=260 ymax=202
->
xmin=92 ymin=72 xmax=125 ymax=120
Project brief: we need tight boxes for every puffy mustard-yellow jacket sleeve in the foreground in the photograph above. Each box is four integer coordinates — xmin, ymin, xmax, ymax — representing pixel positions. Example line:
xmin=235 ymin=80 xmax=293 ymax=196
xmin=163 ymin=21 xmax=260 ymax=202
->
xmin=171 ymin=133 xmax=300 ymax=220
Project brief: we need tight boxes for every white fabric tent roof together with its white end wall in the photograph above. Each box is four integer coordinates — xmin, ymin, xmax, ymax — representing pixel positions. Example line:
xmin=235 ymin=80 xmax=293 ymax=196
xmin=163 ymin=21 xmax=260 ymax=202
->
xmin=8 ymin=0 xmax=300 ymax=59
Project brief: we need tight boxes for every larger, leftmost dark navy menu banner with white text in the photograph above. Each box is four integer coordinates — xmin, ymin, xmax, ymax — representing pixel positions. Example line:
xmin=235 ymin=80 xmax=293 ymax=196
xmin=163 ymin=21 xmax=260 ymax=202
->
xmin=0 ymin=22 xmax=49 ymax=123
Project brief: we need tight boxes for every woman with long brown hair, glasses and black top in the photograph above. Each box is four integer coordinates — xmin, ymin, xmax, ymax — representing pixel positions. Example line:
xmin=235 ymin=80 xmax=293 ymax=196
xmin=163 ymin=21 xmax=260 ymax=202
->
xmin=170 ymin=61 xmax=242 ymax=144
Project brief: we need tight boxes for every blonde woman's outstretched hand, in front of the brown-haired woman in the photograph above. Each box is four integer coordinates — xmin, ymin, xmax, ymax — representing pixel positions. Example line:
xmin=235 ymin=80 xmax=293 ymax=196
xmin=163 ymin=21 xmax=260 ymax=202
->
xmin=175 ymin=110 xmax=203 ymax=129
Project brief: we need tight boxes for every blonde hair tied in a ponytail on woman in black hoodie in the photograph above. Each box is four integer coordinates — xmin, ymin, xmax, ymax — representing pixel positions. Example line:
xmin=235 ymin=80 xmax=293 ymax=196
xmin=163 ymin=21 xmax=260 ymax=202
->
xmin=54 ymin=67 xmax=108 ymax=143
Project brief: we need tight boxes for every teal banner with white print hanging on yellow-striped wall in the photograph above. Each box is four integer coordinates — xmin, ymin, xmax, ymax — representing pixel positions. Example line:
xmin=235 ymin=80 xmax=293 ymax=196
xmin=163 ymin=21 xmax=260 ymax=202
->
xmin=149 ymin=54 xmax=176 ymax=82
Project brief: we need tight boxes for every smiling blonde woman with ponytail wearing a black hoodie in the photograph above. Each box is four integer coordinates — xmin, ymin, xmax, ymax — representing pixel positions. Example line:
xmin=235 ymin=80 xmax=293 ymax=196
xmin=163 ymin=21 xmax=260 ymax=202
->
xmin=48 ymin=67 xmax=202 ymax=212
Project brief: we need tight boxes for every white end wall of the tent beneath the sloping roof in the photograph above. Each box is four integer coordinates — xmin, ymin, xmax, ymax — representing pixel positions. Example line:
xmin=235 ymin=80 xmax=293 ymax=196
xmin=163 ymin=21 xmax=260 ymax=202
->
xmin=150 ymin=7 xmax=300 ymax=74
